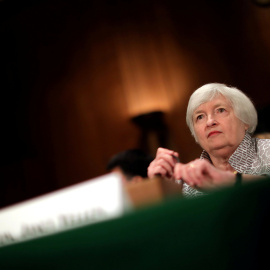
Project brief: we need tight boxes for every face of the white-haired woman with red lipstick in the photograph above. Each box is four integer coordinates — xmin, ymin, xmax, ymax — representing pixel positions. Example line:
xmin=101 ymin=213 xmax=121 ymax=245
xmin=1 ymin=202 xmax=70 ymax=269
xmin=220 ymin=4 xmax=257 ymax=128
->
xmin=193 ymin=95 xmax=248 ymax=154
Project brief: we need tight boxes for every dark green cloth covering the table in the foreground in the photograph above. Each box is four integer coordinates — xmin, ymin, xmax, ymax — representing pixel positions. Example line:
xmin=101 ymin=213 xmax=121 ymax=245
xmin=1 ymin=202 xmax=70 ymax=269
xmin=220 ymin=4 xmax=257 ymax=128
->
xmin=0 ymin=179 xmax=270 ymax=270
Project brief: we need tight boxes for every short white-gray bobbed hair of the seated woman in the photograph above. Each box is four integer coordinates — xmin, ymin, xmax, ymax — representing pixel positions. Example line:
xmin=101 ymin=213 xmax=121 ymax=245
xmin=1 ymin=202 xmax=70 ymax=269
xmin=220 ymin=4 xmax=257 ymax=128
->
xmin=186 ymin=83 xmax=258 ymax=141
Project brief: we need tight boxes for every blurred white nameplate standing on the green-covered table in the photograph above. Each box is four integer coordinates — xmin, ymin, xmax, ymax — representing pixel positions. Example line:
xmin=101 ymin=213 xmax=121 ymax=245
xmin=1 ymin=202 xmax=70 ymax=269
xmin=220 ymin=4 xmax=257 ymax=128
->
xmin=0 ymin=173 xmax=131 ymax=246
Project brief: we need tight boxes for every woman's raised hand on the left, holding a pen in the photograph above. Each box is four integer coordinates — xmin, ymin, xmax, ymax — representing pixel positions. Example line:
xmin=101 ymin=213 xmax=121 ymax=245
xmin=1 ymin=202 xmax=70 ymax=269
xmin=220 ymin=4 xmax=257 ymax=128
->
xmin=148 ymin=147 xmax=179 ymax=179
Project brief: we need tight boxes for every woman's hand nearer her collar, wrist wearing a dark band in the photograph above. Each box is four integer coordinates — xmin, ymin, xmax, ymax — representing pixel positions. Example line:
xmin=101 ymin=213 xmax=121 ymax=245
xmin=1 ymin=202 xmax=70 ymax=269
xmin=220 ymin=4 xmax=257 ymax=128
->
xmin=174 ymin=159 xmax=235 ymax=189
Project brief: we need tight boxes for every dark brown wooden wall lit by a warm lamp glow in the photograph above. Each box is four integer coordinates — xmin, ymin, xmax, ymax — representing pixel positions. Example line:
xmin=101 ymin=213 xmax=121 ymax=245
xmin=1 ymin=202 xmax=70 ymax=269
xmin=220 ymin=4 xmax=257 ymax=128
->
xmin=0 ymin=0 xmax=270 ymax=206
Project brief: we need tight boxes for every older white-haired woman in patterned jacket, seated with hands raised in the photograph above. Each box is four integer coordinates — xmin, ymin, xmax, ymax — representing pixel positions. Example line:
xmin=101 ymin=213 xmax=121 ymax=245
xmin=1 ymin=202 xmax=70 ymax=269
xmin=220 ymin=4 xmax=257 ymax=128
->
xmin=148 ymin=83 xmax=270 ymax=196
